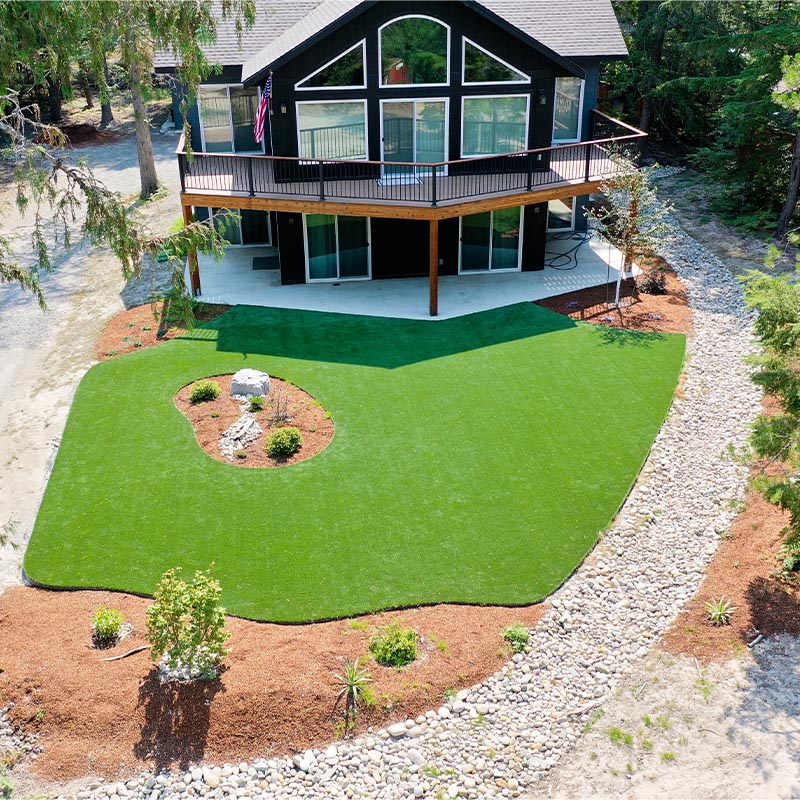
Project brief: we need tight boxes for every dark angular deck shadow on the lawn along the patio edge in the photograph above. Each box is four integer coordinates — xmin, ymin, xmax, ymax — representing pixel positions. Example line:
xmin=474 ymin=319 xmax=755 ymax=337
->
xmin=178 ymin=303 xmax=663 ymax=369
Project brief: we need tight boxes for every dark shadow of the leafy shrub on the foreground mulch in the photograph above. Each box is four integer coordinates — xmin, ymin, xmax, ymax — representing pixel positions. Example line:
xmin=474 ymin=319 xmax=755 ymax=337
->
xmin=133 ymin=669 xmax=225 ymax=772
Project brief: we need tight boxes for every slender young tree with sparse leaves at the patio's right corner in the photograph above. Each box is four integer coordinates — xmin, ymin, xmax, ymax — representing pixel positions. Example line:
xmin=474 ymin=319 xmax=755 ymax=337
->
xmin=586 ymin=164 xmax=670 ymax=306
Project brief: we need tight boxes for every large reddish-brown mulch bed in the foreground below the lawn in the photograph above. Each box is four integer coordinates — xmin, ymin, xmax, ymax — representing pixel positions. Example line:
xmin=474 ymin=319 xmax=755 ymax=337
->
xmin=0 ymin=587 xmax=545 ymax=781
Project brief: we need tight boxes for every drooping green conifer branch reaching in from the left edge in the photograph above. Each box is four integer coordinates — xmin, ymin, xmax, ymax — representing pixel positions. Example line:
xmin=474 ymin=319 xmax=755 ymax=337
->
xmin=0 ymin=93 xmax=234 ymax=316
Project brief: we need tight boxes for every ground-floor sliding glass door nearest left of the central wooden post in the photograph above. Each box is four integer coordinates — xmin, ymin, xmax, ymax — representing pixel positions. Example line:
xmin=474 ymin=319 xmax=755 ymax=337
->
xmin=303 ymin=214 xmax=370 ymax=281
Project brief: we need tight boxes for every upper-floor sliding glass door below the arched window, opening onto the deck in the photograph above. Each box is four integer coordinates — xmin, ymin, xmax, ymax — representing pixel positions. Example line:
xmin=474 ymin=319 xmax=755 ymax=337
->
xmin=381 ymin=100 xmax=447 ymax=178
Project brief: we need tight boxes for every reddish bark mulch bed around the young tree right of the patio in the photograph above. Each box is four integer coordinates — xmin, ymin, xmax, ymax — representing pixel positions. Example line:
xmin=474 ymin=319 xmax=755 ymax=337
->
xmin=537 ymin=255 xmax=692 ymax=333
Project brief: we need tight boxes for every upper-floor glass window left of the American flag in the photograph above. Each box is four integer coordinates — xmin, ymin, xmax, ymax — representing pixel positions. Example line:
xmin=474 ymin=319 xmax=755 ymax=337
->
xmin=197 ymin=86 xmax=263 ymax=153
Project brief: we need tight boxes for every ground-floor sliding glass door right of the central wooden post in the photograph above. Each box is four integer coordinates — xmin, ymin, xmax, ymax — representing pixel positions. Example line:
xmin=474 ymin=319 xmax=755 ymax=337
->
xmin=459 ymin=207 xmax=522 ymax=272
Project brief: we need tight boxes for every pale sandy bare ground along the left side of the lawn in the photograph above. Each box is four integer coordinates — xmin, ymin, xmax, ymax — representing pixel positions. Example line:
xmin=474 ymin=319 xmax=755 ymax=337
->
xmin=0 ymin=100 xmax=180 ymax=590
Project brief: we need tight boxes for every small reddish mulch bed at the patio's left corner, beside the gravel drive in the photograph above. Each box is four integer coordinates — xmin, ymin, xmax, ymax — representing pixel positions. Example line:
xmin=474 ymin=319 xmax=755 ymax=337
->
xmin=96 ymin=303 xmax=230 ymax=361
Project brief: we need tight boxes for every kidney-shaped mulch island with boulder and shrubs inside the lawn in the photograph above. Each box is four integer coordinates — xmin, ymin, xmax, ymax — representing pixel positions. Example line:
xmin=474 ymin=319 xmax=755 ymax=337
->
xmin=175 ymin=375 xmax=334 ymax=467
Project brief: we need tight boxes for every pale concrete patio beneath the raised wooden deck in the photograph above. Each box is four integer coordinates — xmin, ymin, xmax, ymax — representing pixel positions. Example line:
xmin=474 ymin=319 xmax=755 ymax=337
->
xmin=187 ymin=233 xmax=638 ymax=320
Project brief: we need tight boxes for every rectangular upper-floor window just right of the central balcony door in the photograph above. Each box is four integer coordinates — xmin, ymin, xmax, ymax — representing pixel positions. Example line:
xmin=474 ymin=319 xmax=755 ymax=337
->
xmin=461 ymin=95 xmax=528 ymax=158
